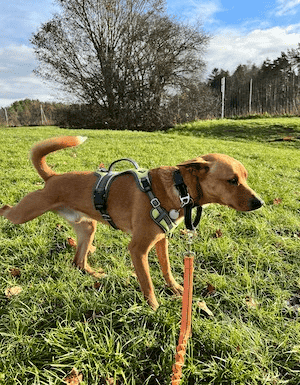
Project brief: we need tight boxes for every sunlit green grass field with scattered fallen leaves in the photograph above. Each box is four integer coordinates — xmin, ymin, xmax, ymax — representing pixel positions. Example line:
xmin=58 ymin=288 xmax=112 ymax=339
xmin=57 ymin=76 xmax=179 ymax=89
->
xmin=0 ymin=118 xmax=300 ymax=385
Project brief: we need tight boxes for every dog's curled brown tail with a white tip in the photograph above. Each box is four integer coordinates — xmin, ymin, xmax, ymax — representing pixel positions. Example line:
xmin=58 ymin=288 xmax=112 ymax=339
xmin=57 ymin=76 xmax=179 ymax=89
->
xmin=31 ymin=136 xmax=87 ymax=181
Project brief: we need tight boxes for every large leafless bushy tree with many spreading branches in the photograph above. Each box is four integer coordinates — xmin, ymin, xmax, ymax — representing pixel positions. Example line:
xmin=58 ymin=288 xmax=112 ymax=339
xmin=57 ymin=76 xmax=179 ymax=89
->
xmin=32 ymin=0 xmax=208 ymax=128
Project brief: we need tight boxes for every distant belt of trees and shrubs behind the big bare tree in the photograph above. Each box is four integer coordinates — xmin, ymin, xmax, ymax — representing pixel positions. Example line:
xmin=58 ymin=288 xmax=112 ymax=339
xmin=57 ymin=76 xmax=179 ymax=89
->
xmin=0 ymin=44 xmax=300 ymax=131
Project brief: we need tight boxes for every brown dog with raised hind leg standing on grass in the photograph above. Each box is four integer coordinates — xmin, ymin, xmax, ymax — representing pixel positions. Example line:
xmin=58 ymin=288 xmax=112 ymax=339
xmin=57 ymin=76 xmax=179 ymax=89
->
xmin=0 ymin=137 xmax=263 ymax=309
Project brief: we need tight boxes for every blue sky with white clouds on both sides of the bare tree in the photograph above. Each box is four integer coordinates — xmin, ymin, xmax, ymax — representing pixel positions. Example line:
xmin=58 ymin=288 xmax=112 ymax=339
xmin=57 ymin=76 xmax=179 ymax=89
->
xmin=0 ymin=0 xmax=300 ymax=108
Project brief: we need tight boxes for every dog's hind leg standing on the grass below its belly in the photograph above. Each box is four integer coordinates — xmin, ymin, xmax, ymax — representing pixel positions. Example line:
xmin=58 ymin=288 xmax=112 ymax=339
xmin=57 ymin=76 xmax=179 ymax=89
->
xmin=69 ymin=218 xmax=104 ymax=278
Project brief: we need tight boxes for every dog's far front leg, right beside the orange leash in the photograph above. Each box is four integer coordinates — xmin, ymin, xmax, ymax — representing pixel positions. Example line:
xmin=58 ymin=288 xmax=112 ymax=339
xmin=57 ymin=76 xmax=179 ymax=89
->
xmin=155 ymin=237 xmax=183 ymax=295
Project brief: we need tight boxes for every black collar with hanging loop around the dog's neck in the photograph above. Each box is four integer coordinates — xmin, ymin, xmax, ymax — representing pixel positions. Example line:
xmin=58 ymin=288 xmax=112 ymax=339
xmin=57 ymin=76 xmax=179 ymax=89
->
xmin=173 ymin=170 xmax=202 ymax=231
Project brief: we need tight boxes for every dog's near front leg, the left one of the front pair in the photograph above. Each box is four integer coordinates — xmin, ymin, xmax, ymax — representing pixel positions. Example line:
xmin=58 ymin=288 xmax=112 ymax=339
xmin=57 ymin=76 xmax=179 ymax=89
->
xmin=128 ymin=238 xmax=159 ymax=310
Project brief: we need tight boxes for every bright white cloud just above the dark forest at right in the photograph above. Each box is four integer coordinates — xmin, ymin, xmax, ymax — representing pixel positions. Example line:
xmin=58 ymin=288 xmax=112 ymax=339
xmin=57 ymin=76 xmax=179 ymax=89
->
xmin=205 ymin=24 xmax=300 ymax=73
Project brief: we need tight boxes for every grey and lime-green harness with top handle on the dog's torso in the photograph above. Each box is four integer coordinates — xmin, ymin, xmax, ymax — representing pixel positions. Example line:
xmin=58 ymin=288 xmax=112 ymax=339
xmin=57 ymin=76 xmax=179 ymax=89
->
xmin=94 ymin=158 xmax=177 ymax=233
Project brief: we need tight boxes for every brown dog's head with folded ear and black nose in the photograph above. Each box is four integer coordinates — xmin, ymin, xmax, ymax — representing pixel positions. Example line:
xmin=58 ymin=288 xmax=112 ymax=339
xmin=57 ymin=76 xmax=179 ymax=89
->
xmin=177 ymin=154 xmax=263 ymax=211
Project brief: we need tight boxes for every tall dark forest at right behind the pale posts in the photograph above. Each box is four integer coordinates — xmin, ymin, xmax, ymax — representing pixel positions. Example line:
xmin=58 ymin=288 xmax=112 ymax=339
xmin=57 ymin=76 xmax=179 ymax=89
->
xmin=208 ymin=44 xmax=300 ymax=117
